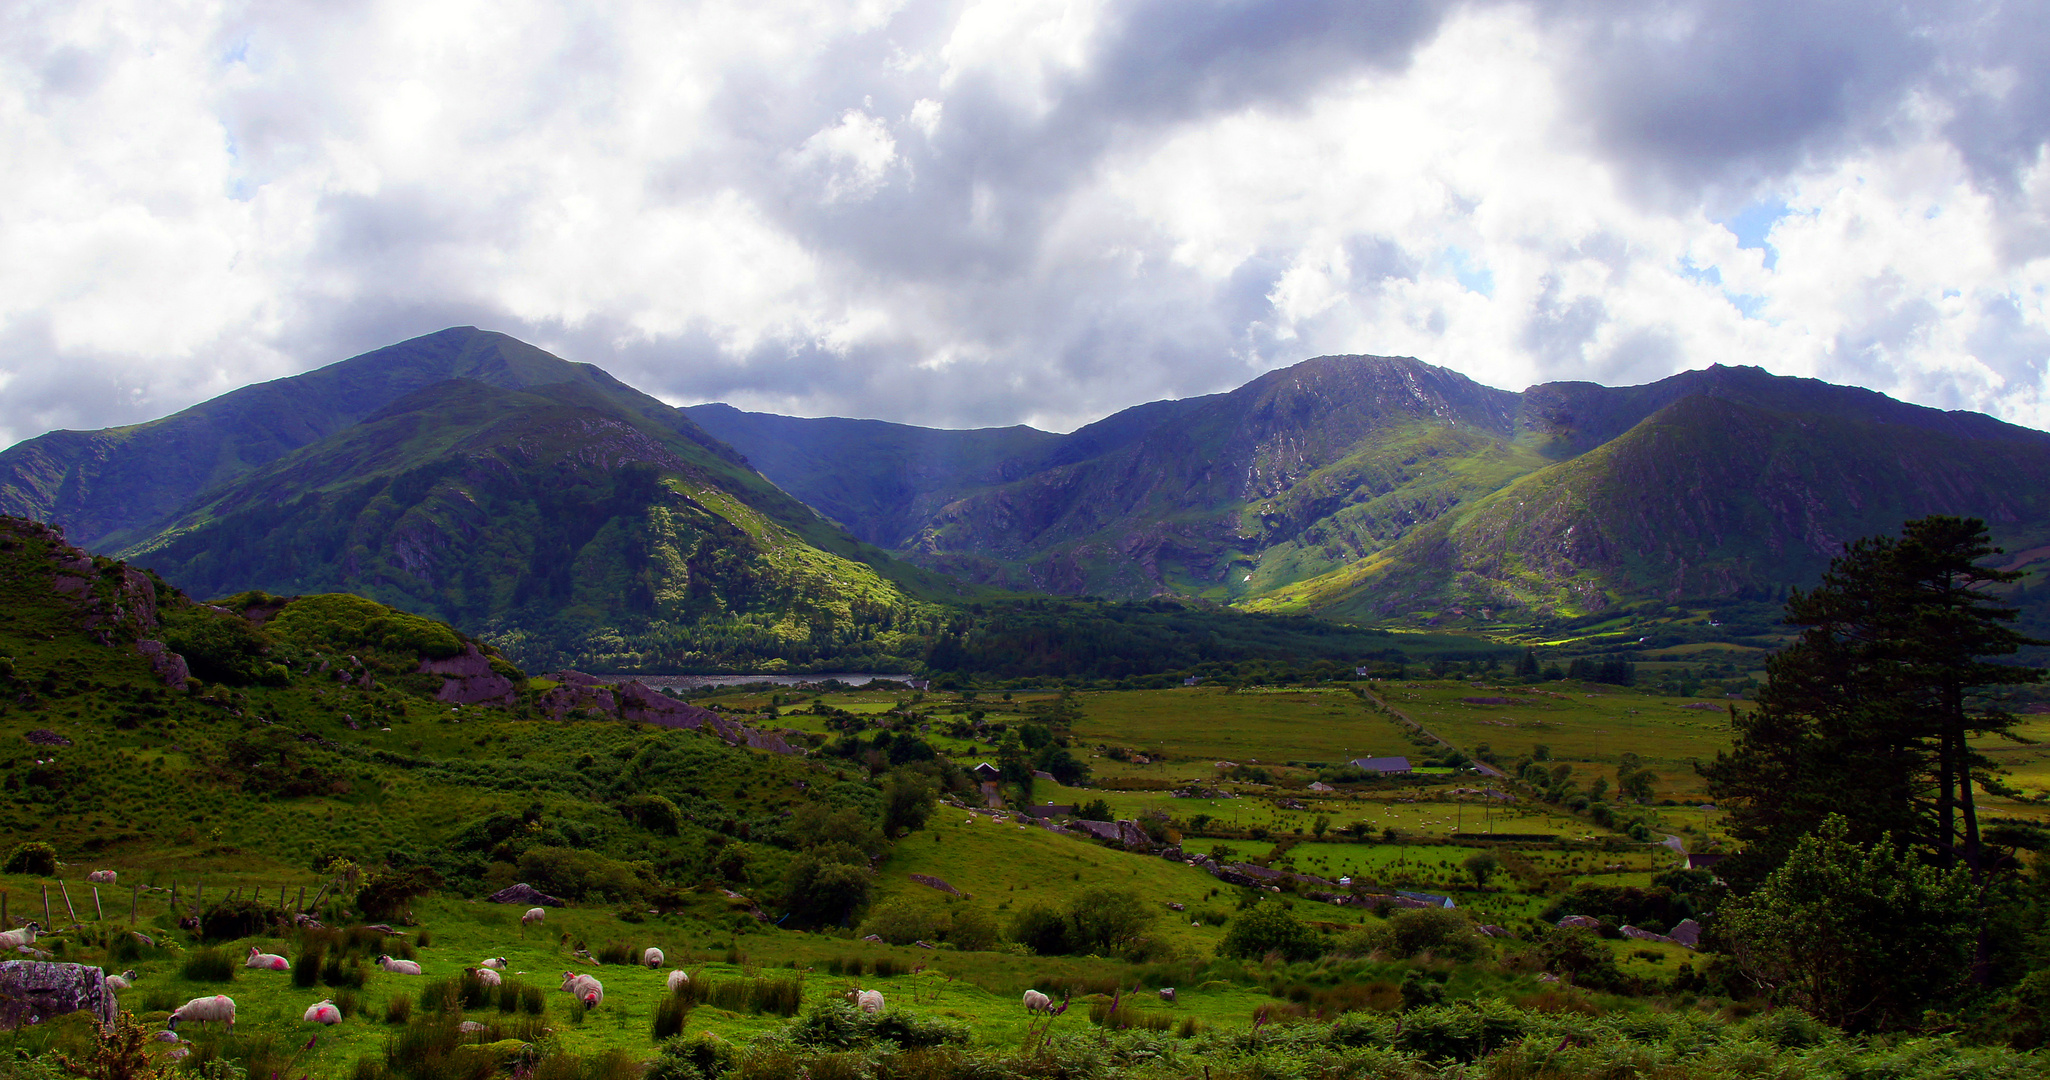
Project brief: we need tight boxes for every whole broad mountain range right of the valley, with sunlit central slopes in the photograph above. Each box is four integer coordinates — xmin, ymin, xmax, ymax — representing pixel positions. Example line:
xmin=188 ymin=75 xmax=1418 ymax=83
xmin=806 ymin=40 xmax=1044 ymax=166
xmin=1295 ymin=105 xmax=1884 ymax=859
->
xmin=691 ymin=357 xmax=2050 ymax=621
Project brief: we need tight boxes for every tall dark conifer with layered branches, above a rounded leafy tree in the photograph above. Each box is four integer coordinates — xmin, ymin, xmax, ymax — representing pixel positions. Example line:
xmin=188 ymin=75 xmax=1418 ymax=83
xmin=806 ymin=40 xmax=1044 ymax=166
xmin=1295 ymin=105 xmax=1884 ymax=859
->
xmin=1702 ymin=516 xmax=2042 ymax=883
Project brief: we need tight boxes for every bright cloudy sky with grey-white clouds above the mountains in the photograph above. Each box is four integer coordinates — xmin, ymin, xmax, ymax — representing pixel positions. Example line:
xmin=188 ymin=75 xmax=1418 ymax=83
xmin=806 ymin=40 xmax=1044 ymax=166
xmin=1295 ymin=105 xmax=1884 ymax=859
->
xmin=0 ymin=0 xmax=2050 ymax=443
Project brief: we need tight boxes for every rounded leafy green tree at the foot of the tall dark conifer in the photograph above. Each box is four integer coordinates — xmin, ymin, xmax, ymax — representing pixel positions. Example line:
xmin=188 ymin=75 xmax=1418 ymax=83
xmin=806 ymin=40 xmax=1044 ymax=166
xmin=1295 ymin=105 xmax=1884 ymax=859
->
xmin=1716 ymin=814 xmax=1976 ymax=1031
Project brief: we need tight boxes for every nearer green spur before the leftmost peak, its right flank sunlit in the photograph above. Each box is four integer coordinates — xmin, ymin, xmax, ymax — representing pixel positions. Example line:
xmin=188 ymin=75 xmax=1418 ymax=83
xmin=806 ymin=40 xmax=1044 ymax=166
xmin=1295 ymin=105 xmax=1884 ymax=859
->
xmin=112 ymin=379 xmax=931 ymax=670
